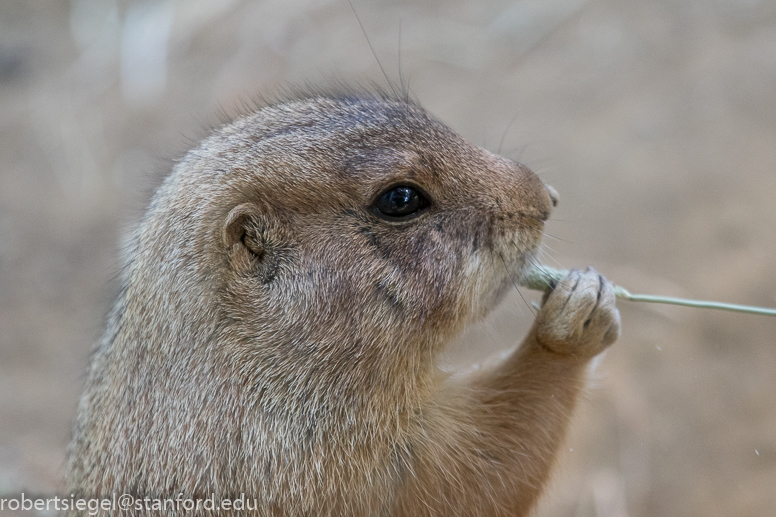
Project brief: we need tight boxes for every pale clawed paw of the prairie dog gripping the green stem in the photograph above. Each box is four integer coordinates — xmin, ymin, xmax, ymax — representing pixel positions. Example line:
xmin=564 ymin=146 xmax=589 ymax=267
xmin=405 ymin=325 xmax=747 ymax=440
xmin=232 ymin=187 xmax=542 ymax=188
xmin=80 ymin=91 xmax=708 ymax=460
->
xmin=535 ymin=268 xmax=620 ymax=358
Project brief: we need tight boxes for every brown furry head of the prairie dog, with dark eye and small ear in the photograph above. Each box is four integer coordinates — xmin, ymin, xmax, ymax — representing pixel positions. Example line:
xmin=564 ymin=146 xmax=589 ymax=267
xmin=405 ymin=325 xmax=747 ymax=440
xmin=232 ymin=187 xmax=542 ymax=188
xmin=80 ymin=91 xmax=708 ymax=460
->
xmin=135 ymin=96 xmax=554 ymax=366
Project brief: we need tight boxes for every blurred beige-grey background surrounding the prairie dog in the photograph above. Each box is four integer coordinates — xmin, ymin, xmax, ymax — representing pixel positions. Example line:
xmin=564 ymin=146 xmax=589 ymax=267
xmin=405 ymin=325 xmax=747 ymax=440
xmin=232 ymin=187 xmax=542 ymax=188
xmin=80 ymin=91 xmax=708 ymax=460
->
xmin=0 ymin=0 xmax=776 ymax=517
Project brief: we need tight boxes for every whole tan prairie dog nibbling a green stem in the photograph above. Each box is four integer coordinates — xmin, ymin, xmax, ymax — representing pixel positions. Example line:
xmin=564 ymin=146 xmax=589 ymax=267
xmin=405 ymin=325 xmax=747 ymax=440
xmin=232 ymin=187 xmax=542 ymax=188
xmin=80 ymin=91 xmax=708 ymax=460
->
xmin=68 ymin=93 xmax=619 ymax=516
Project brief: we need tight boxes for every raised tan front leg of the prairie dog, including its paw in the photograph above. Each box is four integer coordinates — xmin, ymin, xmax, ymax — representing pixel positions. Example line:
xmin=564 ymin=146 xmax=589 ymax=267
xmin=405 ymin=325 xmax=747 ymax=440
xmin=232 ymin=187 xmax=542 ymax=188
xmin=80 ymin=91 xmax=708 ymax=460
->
xmin=399 ymin=269 xmax=620 ymax=516
